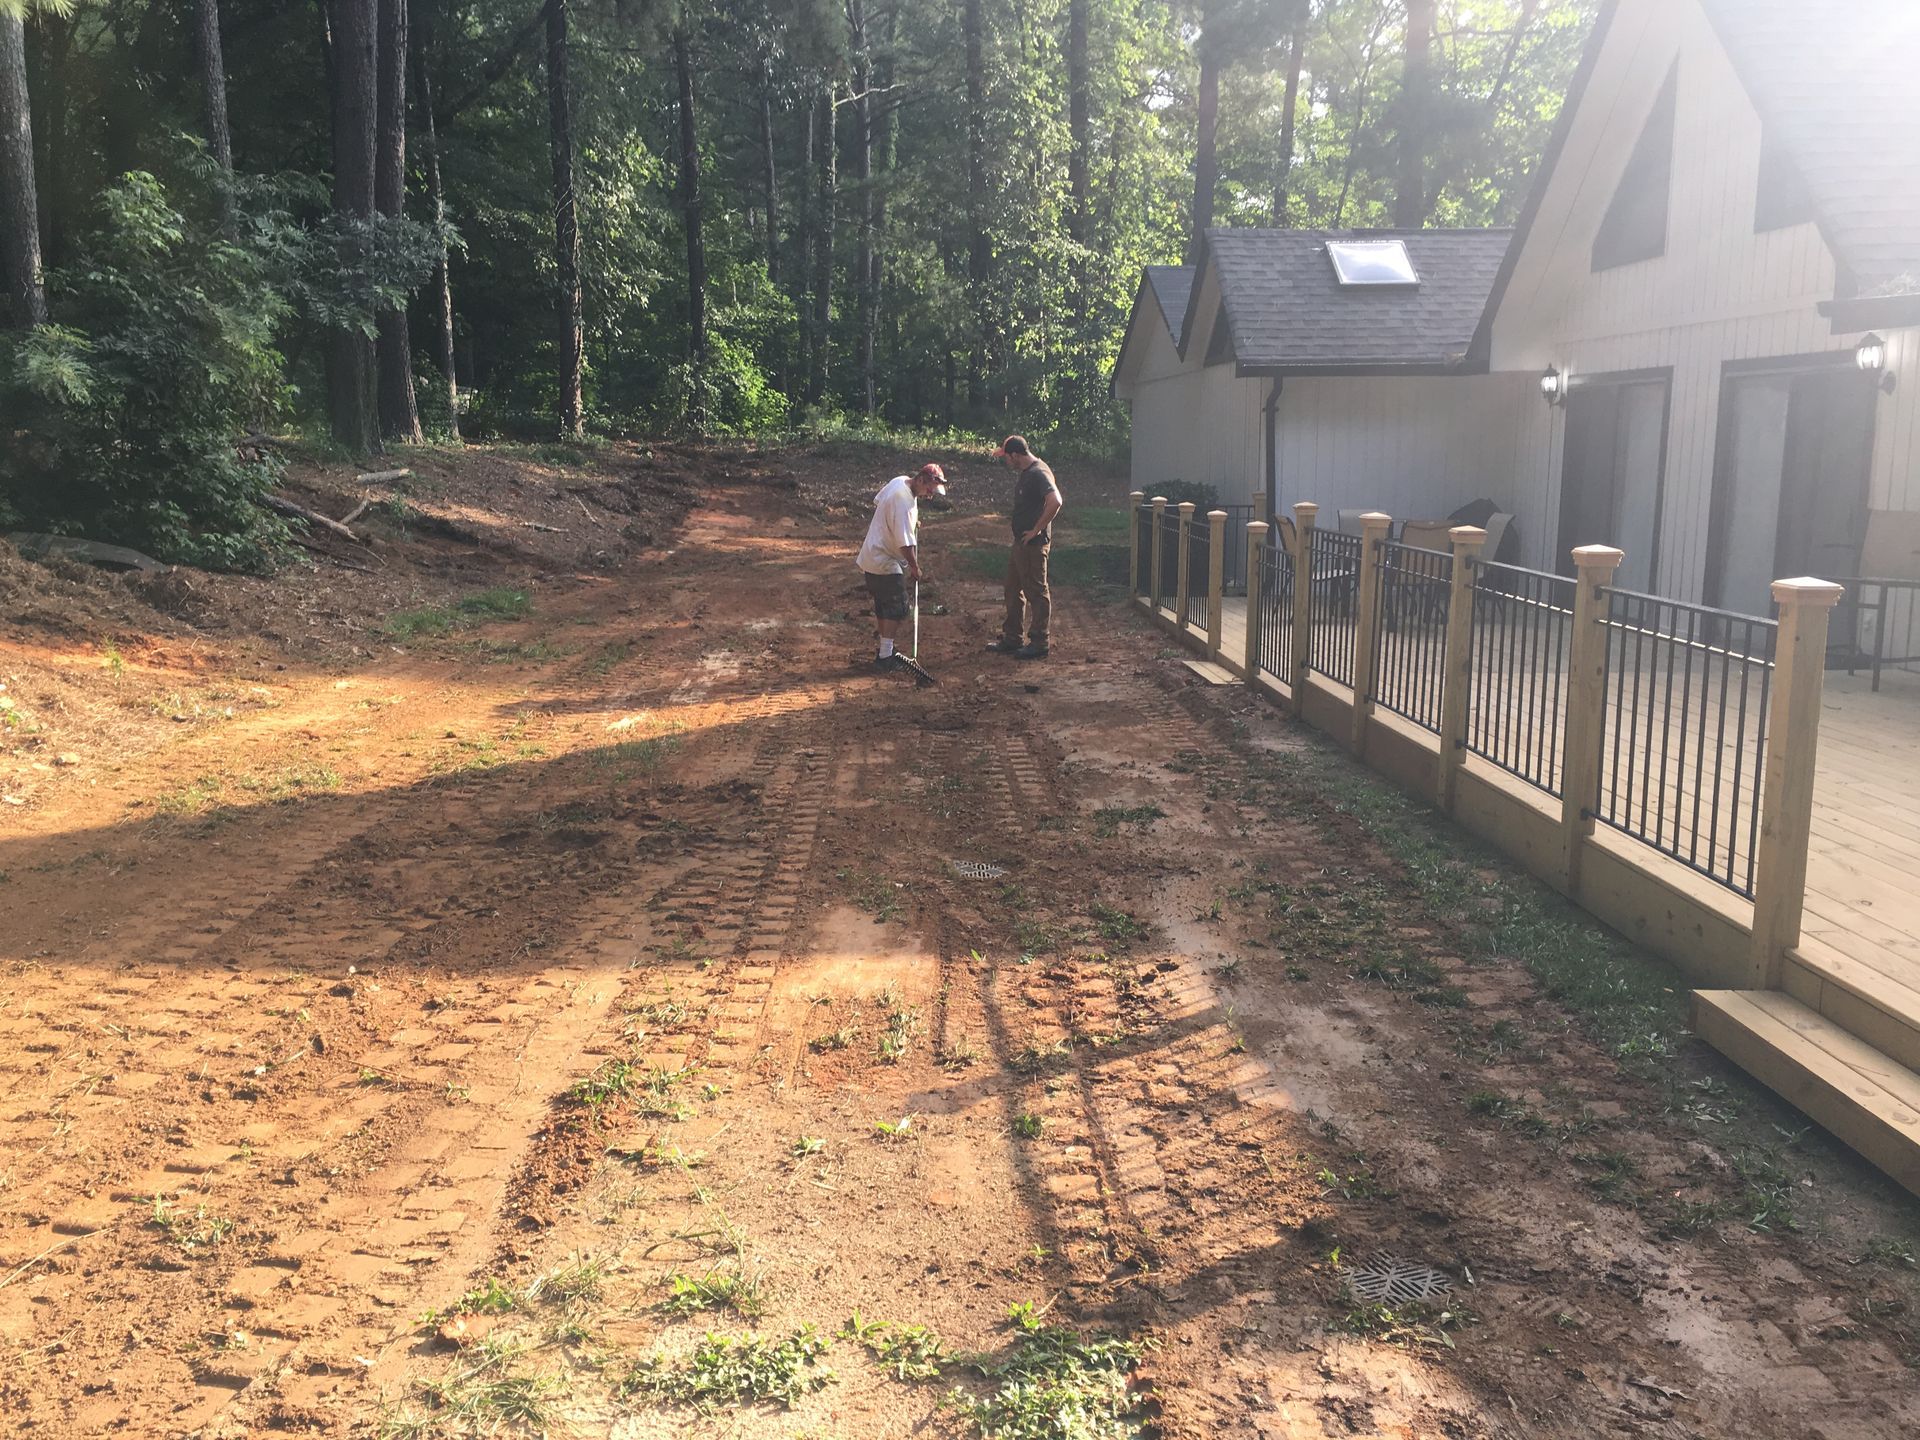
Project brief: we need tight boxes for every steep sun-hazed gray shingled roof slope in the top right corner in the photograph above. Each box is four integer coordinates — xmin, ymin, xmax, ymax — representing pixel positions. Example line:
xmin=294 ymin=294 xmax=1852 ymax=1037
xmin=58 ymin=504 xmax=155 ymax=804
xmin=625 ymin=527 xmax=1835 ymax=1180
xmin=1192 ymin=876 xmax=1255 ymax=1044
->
xmin=1701 ymin=0 xmax=1920 ymax=296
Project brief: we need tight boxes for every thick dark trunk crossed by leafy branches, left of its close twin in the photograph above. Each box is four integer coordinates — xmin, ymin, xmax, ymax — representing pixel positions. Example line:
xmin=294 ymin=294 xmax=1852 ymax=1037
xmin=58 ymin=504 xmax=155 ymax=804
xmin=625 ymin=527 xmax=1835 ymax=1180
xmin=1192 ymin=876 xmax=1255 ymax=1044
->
xmin=326 ymin=0 xmax=380 ymax=455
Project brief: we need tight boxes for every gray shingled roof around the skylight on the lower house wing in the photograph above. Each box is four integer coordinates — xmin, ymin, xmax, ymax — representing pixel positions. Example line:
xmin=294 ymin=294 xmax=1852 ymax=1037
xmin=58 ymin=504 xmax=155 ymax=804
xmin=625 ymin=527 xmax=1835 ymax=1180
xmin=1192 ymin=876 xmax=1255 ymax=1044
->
xmin=1181 ymin=230 xmax=1511 ymax=371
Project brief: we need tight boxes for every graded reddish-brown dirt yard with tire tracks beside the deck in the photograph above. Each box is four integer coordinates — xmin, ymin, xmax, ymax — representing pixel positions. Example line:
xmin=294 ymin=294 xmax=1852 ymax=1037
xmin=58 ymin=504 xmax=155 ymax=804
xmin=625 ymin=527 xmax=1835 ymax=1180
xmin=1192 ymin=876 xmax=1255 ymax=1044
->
xmin=0 ymin=449 xmax=1920 ymax=1440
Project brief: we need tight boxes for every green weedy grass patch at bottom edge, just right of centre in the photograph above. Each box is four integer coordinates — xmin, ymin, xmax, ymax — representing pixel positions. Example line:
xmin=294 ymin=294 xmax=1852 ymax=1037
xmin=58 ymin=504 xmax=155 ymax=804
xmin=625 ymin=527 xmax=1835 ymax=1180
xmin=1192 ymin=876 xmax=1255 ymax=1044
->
xmin=947 ymin=1304 xmax=1146 ymax=1440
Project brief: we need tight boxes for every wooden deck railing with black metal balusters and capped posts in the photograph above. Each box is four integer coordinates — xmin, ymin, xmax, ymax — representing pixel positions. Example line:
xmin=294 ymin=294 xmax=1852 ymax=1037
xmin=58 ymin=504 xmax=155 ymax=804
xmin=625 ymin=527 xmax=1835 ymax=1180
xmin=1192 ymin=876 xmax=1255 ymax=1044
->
xmin=1133 ymin=492 xmax=1841 ymax=987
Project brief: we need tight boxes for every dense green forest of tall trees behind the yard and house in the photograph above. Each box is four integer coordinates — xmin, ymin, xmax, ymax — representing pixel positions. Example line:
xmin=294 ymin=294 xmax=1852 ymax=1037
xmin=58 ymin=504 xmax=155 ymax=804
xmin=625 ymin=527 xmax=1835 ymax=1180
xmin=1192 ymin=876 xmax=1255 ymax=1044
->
xmin=0 ymin=0 xmax=1597 ymax=566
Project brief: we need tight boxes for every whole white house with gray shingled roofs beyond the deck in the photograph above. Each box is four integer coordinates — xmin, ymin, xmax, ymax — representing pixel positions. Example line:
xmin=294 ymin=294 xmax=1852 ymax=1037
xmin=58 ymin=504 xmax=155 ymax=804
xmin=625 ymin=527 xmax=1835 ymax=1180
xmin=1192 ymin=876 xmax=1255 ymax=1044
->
xmin=1114 ymin=0 xmax=1920 ymax=612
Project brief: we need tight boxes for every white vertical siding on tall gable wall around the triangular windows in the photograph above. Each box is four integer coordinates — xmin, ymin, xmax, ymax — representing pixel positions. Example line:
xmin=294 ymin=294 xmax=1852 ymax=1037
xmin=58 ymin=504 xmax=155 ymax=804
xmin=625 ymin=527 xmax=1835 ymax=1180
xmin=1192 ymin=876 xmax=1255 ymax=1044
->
xmin=1492 ymin=0 xmax=1920 ymax=599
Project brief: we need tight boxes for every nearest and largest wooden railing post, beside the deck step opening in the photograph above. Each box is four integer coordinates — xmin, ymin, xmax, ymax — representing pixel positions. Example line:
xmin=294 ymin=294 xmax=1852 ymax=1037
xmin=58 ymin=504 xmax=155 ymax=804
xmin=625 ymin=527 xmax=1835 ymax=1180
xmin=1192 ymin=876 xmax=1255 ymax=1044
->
xmin=1753 ymin=578 xmax=1843 ymax=991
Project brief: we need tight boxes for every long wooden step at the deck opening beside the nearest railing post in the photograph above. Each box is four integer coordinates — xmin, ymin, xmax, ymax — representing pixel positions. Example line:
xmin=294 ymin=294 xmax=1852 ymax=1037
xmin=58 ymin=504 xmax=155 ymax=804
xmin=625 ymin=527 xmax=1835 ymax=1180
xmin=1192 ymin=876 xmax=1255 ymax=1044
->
xmin=1693 ymin=991 xmax=1920 ymax=1194
